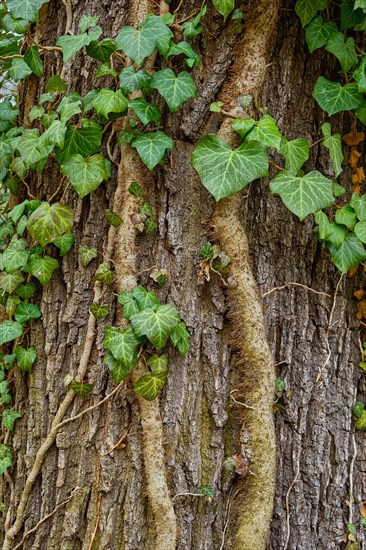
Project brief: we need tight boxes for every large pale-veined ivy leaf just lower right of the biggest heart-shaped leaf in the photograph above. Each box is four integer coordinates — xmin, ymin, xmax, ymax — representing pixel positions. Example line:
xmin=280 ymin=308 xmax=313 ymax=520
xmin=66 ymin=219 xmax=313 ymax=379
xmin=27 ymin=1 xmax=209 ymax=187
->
xmin=270 ymin=170 xmax=334 ymax=221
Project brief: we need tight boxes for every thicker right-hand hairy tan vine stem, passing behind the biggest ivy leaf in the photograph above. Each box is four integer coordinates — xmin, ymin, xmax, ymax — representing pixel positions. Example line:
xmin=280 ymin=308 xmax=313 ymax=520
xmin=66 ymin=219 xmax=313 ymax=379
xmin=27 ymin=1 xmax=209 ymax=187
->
xmin=213 ymin=0 xmax=280 ymax=550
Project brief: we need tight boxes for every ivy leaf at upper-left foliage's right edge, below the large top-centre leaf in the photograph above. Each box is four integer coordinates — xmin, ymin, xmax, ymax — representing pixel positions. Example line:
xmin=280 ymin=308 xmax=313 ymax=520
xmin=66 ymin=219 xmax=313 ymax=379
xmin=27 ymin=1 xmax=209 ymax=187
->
xmin=151 ymin=69 xmax=196 ymax=113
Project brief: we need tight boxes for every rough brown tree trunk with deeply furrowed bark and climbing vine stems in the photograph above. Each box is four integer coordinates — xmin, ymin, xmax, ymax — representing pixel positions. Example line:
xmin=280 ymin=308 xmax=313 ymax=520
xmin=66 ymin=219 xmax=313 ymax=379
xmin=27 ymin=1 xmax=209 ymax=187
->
xmin=2 ymin=0 xmax=366 ymax=550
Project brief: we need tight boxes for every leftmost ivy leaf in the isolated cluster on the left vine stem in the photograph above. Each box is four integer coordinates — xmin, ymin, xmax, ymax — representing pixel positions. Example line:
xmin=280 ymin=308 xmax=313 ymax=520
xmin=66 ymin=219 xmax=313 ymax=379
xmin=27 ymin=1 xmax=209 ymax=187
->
xmin=103 ymin=325 xmax=140 ymax=368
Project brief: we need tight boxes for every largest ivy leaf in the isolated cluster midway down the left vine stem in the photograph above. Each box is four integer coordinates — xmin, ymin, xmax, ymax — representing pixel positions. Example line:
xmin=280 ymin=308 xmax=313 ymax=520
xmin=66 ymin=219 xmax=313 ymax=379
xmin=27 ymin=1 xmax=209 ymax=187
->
xmin=131 ymin=304 xmax=180 ymax=350
